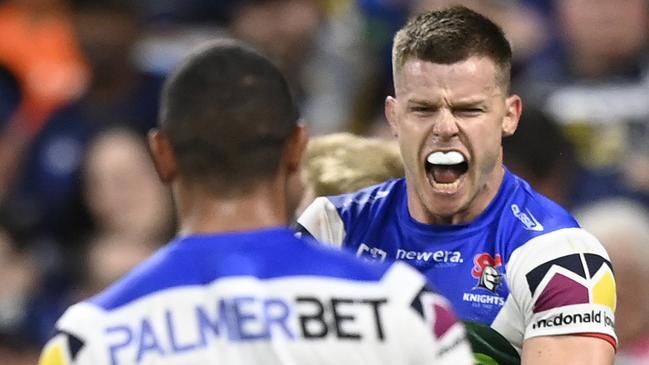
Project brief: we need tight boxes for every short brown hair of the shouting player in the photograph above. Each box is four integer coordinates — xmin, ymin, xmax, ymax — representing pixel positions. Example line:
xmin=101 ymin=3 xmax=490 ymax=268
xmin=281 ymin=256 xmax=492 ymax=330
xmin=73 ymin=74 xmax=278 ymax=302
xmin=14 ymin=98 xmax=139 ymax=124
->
xmin=392 ymin=6 xmax=512 ymax=90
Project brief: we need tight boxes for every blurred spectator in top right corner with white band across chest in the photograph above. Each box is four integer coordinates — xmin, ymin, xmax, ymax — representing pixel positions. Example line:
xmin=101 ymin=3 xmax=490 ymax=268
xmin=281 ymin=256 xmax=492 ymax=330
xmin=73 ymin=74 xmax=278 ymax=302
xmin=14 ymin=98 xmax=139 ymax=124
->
xmin=515 ymin=0 xmax=649 ymax=175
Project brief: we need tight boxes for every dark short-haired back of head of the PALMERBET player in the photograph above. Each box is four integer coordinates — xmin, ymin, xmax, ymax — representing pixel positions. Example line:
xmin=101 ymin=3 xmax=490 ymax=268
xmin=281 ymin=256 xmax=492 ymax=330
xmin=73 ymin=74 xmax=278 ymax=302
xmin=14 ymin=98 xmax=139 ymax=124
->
xmin=160 ymin=39 xmax=299 ymax=195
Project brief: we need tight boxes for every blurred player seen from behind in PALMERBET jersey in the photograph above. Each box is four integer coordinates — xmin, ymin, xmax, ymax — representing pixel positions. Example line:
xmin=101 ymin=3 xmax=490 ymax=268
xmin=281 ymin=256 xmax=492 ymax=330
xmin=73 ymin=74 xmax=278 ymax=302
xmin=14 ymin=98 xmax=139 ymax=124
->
xmin=36 ymin=40 xmax=471 ymax=365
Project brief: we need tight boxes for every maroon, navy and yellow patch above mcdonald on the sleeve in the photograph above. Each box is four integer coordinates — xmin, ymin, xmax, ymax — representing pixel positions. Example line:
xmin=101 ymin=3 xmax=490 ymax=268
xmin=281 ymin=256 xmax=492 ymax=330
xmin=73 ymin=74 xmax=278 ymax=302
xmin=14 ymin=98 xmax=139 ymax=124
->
xmin=526 ymin=253 xmax=616 ymax=313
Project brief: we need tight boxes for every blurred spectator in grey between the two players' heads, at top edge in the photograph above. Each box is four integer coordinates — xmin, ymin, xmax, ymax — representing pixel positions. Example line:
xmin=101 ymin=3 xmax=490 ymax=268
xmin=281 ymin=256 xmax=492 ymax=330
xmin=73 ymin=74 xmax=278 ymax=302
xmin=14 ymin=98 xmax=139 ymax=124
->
xmin=229 ymin=0 xmax=373 ymax=135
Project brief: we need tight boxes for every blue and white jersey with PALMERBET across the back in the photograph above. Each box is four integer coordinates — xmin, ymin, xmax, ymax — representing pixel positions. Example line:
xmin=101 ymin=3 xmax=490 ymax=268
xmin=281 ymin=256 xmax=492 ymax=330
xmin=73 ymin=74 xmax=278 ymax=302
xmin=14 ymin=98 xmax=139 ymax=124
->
xmin=40 ymin=228 xmax=471 ymax=365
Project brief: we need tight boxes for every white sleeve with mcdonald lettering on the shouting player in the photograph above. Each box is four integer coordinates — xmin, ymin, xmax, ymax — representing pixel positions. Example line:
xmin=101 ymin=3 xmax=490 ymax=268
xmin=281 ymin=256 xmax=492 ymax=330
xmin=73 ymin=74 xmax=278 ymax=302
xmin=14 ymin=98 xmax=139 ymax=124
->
xmin=507 ymin=228 xmax=617 ymax=344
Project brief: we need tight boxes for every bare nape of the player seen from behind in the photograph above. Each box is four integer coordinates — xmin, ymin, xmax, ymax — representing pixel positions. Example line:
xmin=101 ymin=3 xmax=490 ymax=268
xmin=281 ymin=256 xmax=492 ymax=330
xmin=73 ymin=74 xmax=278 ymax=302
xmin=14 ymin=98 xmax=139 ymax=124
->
xmin=174 ymin=184 xmax=288 ymax=236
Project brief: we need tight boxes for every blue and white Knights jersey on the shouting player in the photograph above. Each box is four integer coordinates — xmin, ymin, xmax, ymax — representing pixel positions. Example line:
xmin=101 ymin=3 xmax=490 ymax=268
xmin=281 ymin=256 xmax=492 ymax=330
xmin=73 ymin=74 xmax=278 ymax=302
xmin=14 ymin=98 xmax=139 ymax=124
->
xmin=298 ymin=171 xmax=617 ymax=353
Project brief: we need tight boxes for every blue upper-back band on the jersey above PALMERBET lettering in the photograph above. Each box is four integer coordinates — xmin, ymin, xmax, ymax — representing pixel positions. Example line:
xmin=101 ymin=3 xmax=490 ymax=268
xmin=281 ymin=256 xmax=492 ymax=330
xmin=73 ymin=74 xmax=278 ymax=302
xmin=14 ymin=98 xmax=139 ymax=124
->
xmin=89 ymin=228 xmax=389 ymax=310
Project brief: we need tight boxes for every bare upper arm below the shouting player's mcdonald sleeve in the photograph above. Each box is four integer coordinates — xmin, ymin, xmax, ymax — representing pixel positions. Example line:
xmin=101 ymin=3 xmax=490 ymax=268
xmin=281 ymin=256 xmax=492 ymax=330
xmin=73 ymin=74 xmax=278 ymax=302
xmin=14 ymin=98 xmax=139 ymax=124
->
xmin=521 ymin=335 xmax=615 ymax=365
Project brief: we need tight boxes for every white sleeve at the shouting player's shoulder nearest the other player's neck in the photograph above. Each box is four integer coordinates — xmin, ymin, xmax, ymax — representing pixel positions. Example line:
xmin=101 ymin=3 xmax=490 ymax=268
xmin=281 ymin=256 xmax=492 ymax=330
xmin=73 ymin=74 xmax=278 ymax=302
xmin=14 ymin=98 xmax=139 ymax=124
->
xmin=297 ymin=197 xmax=345 ymax=247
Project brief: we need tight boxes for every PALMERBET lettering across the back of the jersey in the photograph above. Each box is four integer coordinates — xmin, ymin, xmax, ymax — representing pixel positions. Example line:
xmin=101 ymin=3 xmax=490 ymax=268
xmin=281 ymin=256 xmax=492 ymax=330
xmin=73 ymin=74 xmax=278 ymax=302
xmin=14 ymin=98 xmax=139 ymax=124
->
xmin=104 ymin=295 xmax=388 ymax=365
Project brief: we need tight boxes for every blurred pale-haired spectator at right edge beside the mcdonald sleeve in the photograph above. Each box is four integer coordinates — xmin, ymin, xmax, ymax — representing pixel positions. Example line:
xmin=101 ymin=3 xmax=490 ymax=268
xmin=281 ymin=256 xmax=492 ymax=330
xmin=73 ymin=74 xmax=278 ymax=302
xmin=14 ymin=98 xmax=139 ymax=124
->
xmin=576 ymin=199 xmax=649 ymax=365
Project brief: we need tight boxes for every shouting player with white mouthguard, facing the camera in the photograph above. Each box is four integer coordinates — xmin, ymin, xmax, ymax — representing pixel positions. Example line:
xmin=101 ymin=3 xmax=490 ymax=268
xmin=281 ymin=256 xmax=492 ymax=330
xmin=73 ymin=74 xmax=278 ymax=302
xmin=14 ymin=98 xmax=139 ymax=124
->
xmin=298 ymin=7 xmax=617 ymax=365
